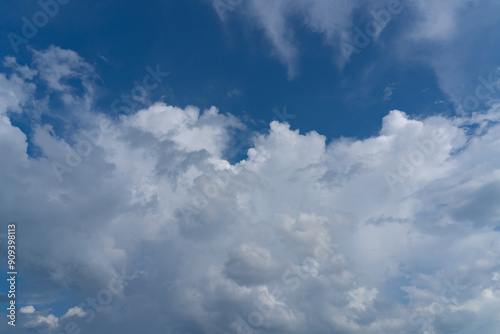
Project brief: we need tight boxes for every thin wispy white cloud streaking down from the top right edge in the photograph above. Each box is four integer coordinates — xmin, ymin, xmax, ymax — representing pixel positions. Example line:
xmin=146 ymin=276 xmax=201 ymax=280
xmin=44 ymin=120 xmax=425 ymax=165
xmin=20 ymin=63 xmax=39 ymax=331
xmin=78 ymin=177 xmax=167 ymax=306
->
xmin=223 ymin=0 xmax=500 ymax=112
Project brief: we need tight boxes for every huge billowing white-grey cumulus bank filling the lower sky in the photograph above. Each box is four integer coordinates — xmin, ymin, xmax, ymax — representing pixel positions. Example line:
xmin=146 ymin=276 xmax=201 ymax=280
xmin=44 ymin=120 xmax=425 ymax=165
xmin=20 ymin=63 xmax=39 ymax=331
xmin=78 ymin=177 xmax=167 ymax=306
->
xmin=0 ymin=47 xmax=500 ymax=334
